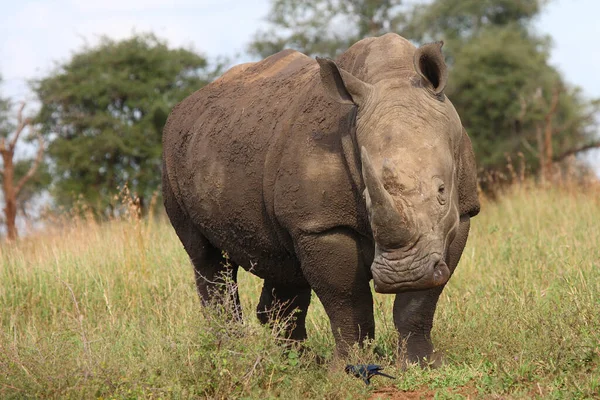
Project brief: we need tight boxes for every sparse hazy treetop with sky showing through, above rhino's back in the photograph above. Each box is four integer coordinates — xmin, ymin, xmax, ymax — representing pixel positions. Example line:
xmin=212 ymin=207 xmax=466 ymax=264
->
xmin=248 ymin=0 xmax=405 ymax=58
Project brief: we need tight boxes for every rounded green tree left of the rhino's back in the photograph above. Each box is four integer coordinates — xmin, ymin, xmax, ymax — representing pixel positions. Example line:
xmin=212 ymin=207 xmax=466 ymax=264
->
xmin=33 ymin=34 xmax=218 ymax=213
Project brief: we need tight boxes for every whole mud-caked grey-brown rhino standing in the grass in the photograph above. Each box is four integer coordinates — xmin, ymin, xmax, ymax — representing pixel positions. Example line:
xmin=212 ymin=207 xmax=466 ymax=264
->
xmin=163 ymin=34 xmax=479 ymax=362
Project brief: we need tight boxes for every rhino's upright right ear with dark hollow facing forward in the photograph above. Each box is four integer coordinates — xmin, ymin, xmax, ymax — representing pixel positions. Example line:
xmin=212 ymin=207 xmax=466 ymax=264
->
xmin=414 ymin=42 xmax=448 ymax=94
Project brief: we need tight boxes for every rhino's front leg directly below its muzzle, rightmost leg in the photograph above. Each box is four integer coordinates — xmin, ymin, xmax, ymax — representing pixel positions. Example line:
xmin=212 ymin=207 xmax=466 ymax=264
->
xmin=394 ymin=217 xmax=470 ymax=367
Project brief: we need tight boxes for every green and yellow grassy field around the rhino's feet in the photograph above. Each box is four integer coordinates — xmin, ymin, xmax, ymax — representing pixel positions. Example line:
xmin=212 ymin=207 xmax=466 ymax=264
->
xmin=0 ymin=188 xmax=600 ymax=399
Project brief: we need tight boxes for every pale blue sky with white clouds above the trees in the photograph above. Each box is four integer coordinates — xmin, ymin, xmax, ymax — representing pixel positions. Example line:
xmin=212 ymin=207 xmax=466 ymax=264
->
xmin=0 ymin=0 xmax=600 ymax=168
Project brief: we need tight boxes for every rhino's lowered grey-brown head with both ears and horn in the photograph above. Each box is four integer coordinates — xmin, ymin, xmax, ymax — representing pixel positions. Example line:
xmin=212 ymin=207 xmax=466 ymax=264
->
xmin=318 ymin=43 xmax=475 ymax=293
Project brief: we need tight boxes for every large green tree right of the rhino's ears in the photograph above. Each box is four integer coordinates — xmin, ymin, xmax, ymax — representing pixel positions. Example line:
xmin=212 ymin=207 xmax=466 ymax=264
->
xmin=406 ymin=0 xmax=599 ymax=175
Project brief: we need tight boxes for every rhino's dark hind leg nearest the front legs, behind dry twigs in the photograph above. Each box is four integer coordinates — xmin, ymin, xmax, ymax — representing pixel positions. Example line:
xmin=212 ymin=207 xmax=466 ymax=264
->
xmin=256 ymin=280 xmax=310 ymax=340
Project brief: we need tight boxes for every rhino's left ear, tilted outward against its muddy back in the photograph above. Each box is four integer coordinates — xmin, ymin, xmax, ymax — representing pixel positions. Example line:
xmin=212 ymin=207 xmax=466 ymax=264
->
xmin=317 ymin=57 xmax=373 ymax=106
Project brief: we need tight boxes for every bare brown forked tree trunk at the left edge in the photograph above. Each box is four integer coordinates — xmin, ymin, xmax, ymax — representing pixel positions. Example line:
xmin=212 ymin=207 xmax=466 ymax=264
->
xmin=0 ymin=99 xmax=44 ymax=240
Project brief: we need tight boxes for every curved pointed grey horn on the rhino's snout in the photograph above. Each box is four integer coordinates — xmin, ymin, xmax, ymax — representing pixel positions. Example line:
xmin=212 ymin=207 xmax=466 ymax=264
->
xmin=361 ymin=147 xmax=414 ymax=249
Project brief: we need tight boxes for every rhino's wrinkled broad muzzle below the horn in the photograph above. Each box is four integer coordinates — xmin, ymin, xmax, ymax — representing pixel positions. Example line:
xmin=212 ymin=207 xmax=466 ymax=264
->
xmin=371 ymin=252 xmax=450 ymax=293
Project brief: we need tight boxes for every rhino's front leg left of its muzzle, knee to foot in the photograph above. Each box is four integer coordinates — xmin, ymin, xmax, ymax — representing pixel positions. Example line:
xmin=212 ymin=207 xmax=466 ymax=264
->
xmin=296 ymin=229 xmax=375 ymax=357
